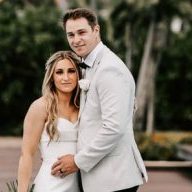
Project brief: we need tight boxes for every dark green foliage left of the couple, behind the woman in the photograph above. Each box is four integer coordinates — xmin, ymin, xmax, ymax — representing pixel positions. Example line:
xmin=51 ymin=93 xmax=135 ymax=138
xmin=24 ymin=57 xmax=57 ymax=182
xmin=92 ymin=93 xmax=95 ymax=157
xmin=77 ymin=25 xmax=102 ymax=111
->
xmin=0 ymin=0 xmax=68 ymax=135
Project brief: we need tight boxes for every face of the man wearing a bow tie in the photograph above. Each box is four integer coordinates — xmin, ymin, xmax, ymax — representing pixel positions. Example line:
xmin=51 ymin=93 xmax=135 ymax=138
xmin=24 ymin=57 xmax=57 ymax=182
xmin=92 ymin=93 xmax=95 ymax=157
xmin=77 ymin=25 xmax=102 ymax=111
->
xmin=66 ymin=17 xmax=100 ymax=58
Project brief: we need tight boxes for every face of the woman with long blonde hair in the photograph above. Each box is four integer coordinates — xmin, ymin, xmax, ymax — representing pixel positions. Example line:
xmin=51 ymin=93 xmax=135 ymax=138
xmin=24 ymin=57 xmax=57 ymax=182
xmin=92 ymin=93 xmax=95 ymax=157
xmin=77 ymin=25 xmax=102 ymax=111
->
xmin=53 ymin=59 xmax=78 ymax=94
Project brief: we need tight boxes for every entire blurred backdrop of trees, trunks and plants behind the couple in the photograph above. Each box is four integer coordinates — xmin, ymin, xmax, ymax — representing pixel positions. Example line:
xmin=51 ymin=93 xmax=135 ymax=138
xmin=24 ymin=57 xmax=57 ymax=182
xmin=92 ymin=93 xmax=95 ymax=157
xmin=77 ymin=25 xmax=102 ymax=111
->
xmin=0 ymin=0 xmax=192 ymax=153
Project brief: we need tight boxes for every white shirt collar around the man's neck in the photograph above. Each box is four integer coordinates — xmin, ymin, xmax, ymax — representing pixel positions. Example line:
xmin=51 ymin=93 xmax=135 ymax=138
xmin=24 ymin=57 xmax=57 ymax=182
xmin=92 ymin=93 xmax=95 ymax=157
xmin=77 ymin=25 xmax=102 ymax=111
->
xmin=83 ymin=41 xmax=104 ymax=67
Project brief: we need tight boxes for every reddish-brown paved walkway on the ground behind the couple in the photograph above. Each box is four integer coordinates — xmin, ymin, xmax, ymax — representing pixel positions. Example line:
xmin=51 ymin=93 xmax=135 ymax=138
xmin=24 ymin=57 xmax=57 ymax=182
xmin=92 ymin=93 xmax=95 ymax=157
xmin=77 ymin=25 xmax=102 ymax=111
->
xmin=0 ymin=138 xmax=192 ymax=192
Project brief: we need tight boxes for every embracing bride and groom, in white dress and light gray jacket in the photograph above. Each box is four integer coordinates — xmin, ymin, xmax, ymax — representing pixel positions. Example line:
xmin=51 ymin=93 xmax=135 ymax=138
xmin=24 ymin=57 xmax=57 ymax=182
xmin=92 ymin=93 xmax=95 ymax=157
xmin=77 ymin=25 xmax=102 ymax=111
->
xmin=18 ymin=8 xmax=147 ymax=192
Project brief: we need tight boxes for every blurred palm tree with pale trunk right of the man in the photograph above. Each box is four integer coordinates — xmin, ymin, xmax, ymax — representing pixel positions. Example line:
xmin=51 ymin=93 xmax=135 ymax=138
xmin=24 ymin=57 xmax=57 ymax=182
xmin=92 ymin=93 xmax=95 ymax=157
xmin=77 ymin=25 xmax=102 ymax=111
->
xmin=112 ymin=0 xmax=191 ymax=134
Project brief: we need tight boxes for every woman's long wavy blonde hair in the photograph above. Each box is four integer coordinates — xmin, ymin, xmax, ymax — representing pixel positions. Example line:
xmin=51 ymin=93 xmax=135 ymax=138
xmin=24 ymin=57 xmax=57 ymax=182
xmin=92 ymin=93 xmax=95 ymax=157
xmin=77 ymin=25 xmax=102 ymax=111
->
xmin=42 ymin=51 xmax=81 ymax=141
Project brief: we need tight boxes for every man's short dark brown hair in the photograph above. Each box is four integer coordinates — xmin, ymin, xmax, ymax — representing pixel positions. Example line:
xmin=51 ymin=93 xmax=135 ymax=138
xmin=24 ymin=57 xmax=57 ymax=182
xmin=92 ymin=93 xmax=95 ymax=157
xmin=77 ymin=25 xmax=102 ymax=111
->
xmin=63 ymin=8 xmax=98 ymax=29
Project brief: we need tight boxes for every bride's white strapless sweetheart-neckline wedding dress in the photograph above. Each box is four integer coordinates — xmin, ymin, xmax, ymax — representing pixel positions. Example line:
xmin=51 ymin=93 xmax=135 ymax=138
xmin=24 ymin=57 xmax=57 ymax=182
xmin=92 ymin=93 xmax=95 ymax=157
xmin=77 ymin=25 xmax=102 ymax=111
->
xmin=34 ymin=118 xmax=79 ymax=192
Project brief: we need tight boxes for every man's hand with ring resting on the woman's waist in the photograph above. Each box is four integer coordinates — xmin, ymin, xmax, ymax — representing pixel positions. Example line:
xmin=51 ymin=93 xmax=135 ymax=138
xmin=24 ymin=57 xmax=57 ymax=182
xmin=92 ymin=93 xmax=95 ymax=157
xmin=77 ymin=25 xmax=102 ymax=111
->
xmin=51 ymin=155 xmax=79 ymax=177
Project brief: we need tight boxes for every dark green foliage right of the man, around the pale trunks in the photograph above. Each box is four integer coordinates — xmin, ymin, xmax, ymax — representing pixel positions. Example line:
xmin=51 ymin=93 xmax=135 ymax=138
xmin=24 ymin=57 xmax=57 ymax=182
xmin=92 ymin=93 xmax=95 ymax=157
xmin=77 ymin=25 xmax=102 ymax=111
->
xmin=111 ymin=0 xmax=192 ymax=130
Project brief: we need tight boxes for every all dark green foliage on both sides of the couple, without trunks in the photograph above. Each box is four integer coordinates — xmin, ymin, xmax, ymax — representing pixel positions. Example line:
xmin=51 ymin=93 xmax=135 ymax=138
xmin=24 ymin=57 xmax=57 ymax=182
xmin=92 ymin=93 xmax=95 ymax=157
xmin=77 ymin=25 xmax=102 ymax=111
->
xmin=0 ymin=0 xmax=192 ymax=135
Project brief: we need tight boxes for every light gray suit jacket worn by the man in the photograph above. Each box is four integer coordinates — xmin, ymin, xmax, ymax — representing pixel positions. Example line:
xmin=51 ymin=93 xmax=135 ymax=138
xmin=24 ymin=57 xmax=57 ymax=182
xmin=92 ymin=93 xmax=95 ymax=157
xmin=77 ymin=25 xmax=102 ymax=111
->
xmin=75 ymin=46 xmax=148 ymax=192
